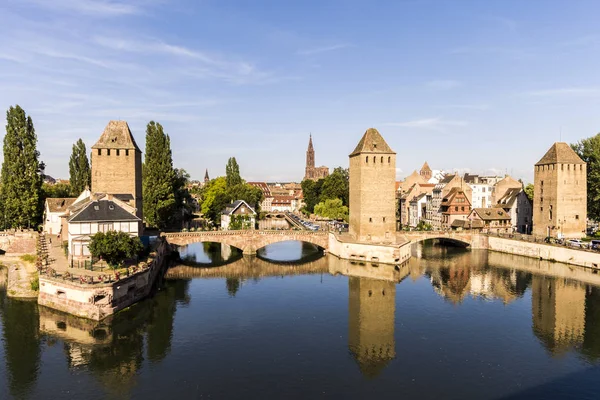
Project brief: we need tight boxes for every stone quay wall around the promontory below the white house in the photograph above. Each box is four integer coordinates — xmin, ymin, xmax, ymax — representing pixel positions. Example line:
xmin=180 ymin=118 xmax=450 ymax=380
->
xmin=38 ymin=239 xmax=170 ymax=321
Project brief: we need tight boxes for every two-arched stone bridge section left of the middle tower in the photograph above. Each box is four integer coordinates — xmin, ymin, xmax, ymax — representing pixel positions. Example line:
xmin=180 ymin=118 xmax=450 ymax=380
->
xmin=162 ymin=230 xmax=329 ymax=255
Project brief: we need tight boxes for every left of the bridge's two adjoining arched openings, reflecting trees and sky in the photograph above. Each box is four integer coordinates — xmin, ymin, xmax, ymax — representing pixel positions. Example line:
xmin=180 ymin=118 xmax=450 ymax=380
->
xmin=177 ymin=242 xmax=243 ymax=267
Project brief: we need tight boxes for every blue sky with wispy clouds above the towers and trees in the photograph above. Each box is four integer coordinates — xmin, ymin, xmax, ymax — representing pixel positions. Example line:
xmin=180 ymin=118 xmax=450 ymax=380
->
xmin=0 ymin=0 xmax=600 ymax=181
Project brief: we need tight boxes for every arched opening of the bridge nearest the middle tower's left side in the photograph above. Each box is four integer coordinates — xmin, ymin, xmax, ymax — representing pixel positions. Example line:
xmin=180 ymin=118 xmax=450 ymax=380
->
xmin=256 ymin=240 xmax=324 ymax=264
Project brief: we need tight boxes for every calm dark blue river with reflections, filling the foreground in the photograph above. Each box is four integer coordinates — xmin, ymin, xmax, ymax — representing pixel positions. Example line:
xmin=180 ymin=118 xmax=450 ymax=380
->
xmin=0 ymin=242 xmax=600 ymax=399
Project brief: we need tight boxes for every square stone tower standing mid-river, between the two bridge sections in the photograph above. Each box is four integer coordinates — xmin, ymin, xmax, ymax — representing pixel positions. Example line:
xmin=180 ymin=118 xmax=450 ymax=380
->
xmin=350 ymin=128 xmax=396 ymax=242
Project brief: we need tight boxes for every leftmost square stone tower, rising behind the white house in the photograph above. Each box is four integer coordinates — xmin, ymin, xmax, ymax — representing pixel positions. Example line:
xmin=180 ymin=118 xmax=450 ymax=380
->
xmin=92 ymin=121 xmax=143 ymax=219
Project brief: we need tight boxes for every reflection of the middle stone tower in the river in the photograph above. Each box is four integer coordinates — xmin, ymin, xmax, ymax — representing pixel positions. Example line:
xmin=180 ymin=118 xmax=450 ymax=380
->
xmin=348 ymin=277 xmax=396 ymax=378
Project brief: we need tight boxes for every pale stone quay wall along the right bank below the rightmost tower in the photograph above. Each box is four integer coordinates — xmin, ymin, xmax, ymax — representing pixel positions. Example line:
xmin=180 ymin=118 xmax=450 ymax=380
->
xmin=488 ymin=236 xmax=600 ymax=269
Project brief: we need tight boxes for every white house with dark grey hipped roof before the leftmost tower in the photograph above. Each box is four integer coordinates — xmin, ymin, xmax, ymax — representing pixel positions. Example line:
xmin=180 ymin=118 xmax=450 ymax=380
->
xmin=63 ymin=192 xmax=141 ymax=259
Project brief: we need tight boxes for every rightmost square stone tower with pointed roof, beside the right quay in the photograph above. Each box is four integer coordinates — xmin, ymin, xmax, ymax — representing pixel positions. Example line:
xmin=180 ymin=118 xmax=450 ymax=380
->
xmin=533 ymin=142 xmax=587 ymax=238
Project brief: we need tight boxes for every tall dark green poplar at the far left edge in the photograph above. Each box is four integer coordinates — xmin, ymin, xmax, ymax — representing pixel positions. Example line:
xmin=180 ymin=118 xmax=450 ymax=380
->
xmin=0 ymin=105 xmax=44 ymax=228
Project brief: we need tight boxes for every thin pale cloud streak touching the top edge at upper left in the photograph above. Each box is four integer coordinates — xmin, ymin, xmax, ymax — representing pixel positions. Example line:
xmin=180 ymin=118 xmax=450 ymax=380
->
xmin=22 ymin=0 xmax=142 ymax=17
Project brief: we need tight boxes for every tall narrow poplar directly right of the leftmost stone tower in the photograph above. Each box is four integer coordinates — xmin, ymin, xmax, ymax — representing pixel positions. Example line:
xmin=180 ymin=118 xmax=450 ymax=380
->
xmin=142 ymin=121 xmax=177 ymax=229
